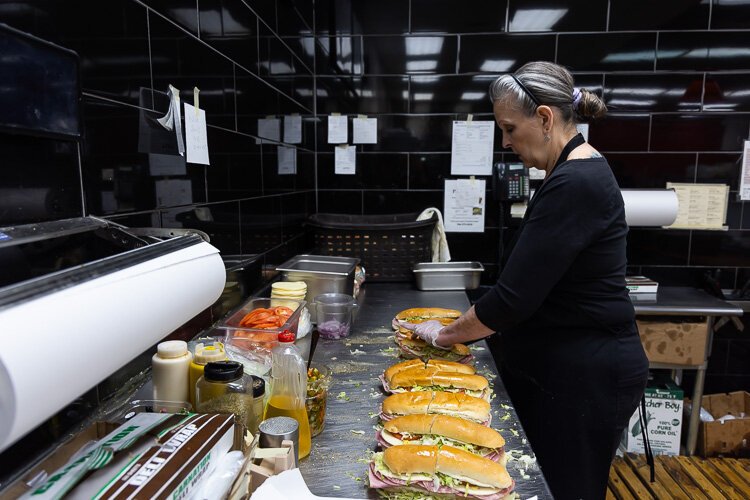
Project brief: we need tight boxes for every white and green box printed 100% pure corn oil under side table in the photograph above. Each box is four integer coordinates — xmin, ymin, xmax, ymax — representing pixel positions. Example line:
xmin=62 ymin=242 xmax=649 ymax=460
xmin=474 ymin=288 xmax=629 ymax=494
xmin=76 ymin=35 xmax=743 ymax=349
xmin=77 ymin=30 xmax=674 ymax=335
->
xmin=622 ymin=386 xmax=683 ymax=455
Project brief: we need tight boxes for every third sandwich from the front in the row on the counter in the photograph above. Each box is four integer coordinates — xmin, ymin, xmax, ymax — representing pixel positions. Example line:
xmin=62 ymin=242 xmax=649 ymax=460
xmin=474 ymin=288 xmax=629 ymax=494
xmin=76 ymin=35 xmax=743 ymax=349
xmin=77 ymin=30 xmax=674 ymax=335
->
xmin=380 ymin=391 xmax=492 ymax=425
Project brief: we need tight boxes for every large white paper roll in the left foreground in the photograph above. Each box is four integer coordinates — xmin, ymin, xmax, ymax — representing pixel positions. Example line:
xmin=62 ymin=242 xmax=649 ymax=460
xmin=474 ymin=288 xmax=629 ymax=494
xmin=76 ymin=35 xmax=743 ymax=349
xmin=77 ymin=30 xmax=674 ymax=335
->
xmin=0 ymin=242 xmax=226 ymax=451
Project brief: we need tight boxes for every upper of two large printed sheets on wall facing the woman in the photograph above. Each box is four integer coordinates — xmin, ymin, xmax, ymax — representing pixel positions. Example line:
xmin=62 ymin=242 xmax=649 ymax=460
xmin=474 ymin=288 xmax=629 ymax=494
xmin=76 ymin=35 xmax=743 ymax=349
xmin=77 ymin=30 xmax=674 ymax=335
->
xmin=451 ymin=121 xmax=495 ymax=175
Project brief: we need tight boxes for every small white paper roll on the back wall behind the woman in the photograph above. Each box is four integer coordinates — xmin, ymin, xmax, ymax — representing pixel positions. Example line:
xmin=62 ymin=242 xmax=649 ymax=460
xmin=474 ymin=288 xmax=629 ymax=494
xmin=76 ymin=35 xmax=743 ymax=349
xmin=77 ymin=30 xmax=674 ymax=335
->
xmin=622 ymin=189 xmax=679 ymax=226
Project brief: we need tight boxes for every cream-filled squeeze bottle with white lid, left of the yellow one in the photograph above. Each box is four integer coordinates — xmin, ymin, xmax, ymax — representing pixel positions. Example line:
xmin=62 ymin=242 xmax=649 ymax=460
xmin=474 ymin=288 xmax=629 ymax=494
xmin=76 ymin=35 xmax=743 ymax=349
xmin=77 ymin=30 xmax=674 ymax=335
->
xmin=151 ymin=340 xmax=192 ymax=411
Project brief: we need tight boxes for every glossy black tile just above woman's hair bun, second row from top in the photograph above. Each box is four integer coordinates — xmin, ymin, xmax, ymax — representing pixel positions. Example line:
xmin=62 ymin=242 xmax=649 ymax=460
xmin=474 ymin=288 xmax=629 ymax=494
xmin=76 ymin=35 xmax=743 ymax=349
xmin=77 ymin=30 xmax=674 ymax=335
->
xmin=557 ymin=33 xmax=656 ymax=71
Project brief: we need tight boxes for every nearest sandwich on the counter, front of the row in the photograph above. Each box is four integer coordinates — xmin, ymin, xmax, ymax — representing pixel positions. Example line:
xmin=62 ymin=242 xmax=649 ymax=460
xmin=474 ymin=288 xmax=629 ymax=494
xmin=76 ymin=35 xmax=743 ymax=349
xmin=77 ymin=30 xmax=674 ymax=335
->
xmin=368 ymin=444 xmax=515 ymax=500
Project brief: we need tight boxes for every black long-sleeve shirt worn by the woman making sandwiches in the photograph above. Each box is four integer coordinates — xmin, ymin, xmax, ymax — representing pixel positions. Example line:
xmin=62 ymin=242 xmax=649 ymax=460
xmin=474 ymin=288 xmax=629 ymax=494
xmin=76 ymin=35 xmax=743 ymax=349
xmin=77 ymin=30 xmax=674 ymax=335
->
xmin=475 ymin=158 xmax=635 ymax=360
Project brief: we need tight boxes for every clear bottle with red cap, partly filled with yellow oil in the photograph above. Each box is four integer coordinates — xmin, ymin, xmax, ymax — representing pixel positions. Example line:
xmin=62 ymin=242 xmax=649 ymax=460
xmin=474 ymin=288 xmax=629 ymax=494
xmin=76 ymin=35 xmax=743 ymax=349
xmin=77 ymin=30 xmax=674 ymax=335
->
xmin=265 ymin=330 xmax=311 ymax=459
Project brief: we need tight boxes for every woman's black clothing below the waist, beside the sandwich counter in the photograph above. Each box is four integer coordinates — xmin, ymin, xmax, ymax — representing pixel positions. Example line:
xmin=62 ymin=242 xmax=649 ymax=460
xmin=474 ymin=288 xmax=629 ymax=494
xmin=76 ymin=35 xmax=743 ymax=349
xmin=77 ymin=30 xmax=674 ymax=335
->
xmin=501 ymin=330 xmax=648 ymax=500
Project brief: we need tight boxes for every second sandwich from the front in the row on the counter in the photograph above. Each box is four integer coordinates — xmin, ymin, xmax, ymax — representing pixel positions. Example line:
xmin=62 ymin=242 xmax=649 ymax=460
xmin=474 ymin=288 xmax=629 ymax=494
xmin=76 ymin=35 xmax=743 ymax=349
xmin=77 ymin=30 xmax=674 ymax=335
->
xmin=377 ymin=415 xmax=507 ymax=465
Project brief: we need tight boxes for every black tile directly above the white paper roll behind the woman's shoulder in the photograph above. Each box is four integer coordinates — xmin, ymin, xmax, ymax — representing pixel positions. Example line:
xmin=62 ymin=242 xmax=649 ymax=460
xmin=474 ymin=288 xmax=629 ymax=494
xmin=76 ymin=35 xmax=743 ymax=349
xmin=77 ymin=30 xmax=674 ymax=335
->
xmin=606 ymin=153 xmax=695 ymax=189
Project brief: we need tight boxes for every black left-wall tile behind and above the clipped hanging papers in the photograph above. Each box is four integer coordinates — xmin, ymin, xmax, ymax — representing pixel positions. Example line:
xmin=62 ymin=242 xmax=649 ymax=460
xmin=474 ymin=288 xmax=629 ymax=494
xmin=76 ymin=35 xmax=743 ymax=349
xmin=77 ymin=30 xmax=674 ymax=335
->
xmin=149 ymin=13 xmax=235 ymax=128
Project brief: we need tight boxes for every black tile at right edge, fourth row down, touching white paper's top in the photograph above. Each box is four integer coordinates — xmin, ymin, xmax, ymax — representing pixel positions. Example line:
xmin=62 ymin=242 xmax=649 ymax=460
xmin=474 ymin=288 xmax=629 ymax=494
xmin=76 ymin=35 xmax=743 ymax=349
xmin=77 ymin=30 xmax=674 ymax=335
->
xmin=651 ymin=113 xmax=750 ymax=151
